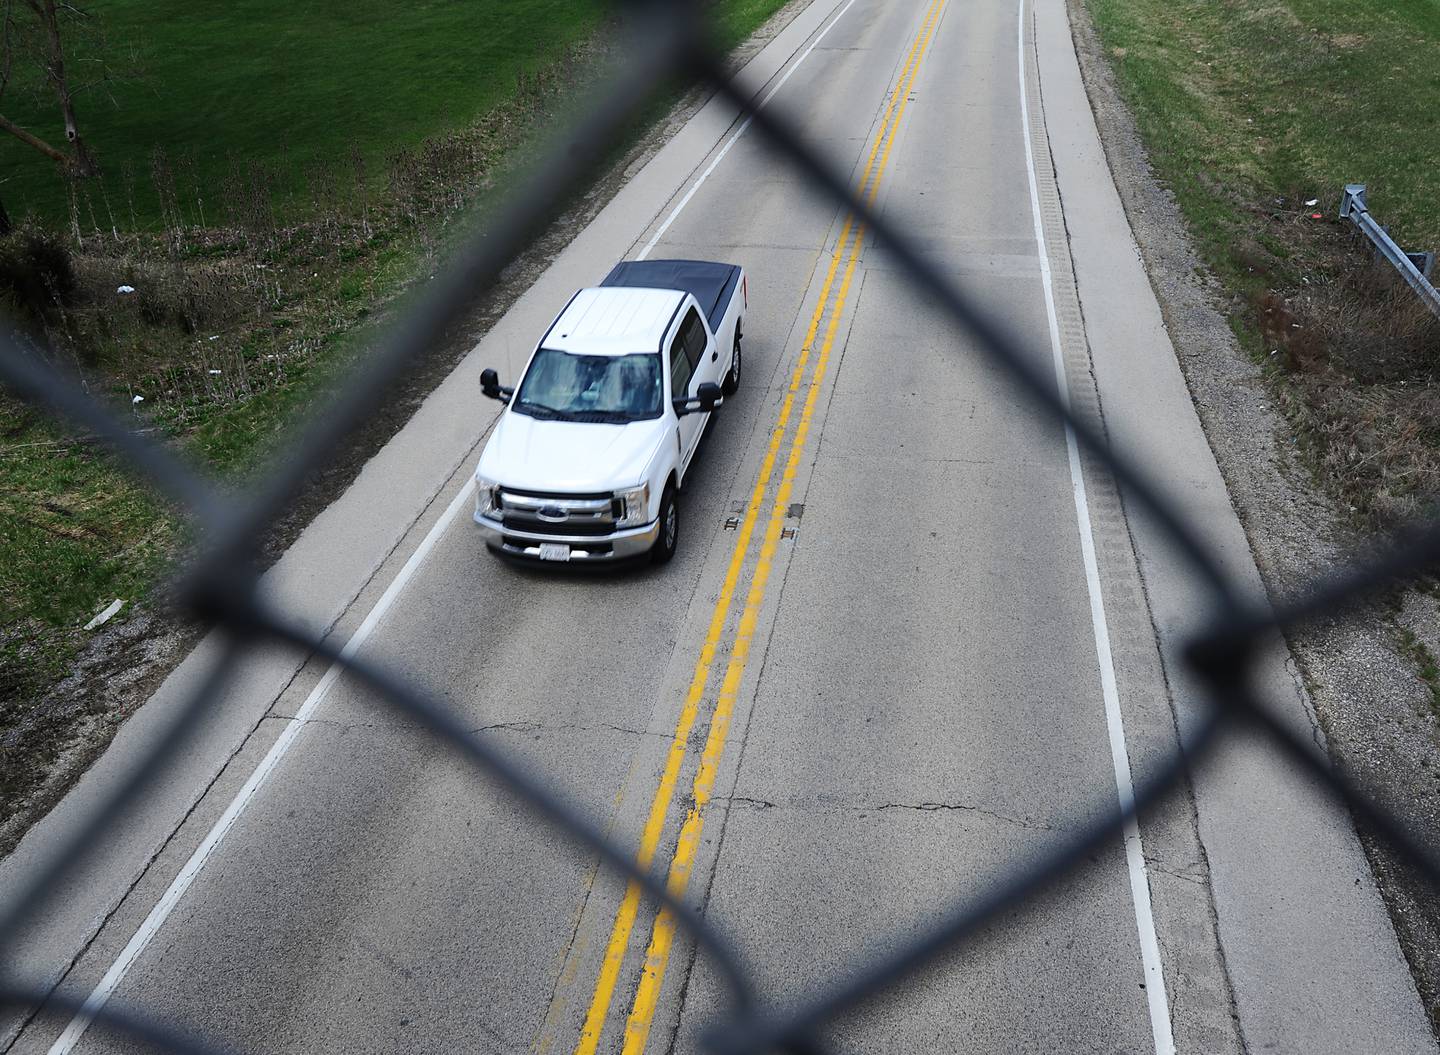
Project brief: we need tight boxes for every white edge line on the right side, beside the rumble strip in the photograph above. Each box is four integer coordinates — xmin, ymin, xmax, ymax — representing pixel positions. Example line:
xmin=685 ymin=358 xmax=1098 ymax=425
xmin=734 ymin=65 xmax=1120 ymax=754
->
xmin=1018 ymin=0 xmax=1175 ymax=1055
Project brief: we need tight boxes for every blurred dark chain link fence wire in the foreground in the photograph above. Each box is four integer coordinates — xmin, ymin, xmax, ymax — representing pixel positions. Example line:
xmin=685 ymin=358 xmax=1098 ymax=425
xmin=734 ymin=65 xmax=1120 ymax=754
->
xmin=0 ymin=0 xmax=1440 ymax=1055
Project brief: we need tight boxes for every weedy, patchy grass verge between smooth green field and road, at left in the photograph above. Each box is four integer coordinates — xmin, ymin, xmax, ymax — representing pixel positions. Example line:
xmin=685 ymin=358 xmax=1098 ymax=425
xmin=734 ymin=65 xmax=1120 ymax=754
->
xmin=0 ymin=0 xmax=800 ymax=851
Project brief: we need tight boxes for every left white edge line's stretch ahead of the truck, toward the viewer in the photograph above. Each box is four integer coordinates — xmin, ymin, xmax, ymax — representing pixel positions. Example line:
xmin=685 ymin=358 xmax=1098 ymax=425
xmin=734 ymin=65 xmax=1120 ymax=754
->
xmin=49 ymin=476 xmax=475 ymax=1055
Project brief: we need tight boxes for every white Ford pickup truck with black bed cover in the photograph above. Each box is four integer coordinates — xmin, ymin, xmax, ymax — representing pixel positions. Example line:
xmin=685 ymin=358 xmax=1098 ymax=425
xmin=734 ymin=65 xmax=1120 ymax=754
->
xmin=475 ymin=261 xmax=749 ymax=563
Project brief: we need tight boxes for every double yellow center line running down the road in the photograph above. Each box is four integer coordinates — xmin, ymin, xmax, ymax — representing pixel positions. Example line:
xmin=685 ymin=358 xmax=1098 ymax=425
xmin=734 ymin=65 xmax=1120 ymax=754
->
xmin=575 ymin=0 xmax=946 ymax=1055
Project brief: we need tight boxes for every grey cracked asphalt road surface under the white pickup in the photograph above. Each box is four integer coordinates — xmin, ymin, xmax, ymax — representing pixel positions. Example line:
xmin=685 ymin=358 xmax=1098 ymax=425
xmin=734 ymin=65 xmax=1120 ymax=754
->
xmin=12 ymin=0 xmax=1434 ymax=1052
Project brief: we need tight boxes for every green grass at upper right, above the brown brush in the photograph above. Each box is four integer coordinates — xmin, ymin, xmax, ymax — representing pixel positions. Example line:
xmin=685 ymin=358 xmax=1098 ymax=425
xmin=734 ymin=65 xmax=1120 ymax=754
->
xmin=1087 ymin=0 xmax=1440 ymax=286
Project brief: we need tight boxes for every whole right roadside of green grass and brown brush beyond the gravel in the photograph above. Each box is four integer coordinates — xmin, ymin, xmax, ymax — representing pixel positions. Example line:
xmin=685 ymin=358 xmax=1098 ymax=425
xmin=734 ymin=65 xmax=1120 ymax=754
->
xmin=1087 ymin=0 xmax=1440 ymax=530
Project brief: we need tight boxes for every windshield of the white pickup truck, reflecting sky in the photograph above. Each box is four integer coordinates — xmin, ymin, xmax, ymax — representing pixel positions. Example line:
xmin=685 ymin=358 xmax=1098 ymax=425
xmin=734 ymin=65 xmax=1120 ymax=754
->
xmin=511 ymin=348 xmax=661 ymax=423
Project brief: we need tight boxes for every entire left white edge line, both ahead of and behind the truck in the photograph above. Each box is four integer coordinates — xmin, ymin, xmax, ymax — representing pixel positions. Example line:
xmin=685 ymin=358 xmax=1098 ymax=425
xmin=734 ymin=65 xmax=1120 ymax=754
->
xmin=49 ymin=0 xmax=855 ymax=1055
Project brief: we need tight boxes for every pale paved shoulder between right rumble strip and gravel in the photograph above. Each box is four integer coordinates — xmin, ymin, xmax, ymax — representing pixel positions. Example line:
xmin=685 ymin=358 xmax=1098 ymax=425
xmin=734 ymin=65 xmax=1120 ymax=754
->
xmin=1037 ymin=3 xmax=1434 ymax=1052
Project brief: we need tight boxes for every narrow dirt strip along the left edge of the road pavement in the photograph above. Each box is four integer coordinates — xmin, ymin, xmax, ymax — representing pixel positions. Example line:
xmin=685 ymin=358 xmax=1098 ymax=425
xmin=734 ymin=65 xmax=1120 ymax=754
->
xmin=0 ymin=0 xmax=811 ymax=856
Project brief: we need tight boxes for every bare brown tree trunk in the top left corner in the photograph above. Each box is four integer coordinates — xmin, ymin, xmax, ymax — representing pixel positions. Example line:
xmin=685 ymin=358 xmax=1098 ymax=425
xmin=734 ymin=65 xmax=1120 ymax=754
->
xmin=0 ymin=0 xmax=99 ymax=177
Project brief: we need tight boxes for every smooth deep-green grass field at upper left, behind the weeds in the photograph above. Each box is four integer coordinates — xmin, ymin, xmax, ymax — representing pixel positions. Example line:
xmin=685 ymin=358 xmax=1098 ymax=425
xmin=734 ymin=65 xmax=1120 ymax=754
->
xmin=0 ymin=0 xmax=605 ymax=226
